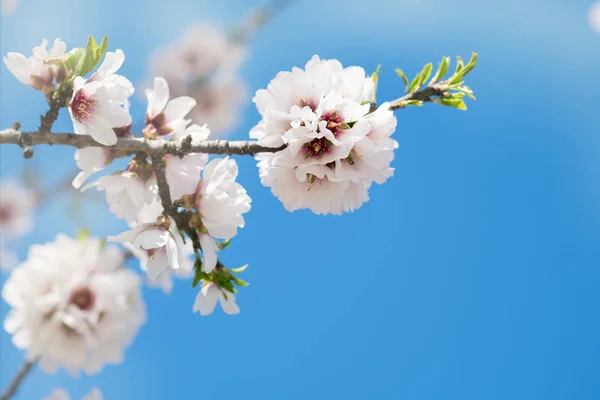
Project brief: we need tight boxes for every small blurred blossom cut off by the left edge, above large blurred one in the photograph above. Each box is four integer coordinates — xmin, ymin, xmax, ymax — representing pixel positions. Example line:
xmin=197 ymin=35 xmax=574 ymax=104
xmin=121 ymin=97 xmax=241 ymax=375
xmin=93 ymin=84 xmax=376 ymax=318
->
xmin=0 ymin=180 xmax=35 ymax=269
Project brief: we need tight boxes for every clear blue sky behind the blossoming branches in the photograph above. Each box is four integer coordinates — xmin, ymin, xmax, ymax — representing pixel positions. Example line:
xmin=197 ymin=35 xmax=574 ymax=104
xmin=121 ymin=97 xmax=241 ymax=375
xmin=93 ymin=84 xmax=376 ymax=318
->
xmin=0 ymin=0 xmax=600 ymax=400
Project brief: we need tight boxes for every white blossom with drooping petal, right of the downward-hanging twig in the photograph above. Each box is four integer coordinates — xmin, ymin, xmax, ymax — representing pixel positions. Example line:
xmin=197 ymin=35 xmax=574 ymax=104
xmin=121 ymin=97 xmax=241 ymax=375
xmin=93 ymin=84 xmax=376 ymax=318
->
xmin=195 ymin=157 xmax=251 ymax=273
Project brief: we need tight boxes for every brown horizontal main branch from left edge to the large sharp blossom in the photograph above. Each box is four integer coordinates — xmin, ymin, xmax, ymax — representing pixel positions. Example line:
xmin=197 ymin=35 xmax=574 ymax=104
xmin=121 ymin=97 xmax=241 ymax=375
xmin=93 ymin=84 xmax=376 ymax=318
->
xmin=0 ymin=128 xmax=285 ymax=158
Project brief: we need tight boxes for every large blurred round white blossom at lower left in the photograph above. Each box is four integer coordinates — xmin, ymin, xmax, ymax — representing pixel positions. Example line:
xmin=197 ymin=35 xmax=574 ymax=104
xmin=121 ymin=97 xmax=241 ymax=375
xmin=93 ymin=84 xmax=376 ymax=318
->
xmin=2 ymin=234 xmax=146 ymax=376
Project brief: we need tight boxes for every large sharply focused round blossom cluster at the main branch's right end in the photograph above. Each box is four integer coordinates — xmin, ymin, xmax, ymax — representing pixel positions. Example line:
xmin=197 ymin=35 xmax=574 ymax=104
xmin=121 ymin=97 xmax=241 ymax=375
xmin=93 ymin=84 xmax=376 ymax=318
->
xmin=250 ymin=56 xmax=398 ymax=214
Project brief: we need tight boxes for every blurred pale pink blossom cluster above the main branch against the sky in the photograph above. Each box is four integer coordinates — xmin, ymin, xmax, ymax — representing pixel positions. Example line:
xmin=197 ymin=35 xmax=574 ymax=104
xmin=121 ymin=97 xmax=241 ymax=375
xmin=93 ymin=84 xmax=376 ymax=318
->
xmin=145 ymin=24 xmax=248 ymax=133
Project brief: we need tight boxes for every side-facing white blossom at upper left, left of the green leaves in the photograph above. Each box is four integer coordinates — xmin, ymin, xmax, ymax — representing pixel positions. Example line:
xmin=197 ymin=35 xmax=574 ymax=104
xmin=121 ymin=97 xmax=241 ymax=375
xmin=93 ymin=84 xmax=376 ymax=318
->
xmin=4 ymin=39 xmax=67 ymax=92
